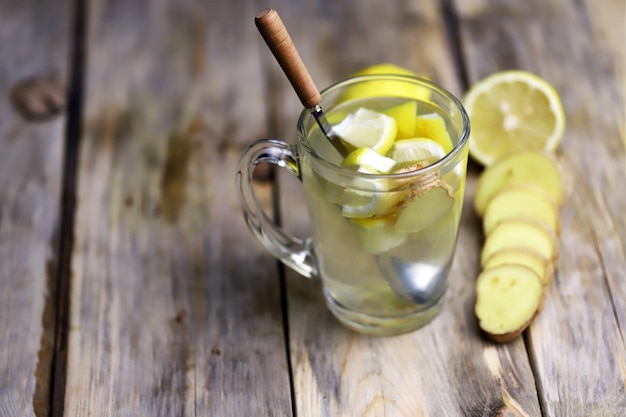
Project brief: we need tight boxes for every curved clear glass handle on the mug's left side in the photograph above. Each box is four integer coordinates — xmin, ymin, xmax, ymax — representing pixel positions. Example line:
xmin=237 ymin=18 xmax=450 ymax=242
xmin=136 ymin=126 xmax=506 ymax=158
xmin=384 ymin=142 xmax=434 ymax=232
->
xmin=237 ymin=139 xmax=318 ymax=279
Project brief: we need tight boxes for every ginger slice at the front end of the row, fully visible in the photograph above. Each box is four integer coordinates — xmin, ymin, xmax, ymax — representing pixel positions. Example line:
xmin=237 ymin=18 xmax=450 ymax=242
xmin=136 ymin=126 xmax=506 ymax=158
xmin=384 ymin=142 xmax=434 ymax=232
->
xmin=475 ymin=265 xmax=542 ymax=342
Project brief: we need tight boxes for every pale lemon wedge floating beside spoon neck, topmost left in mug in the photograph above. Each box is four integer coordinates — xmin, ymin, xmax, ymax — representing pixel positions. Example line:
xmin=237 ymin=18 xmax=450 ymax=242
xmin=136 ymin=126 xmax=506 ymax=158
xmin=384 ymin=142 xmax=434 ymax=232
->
xmin=333 ymin=107 xmax=397 ymax=155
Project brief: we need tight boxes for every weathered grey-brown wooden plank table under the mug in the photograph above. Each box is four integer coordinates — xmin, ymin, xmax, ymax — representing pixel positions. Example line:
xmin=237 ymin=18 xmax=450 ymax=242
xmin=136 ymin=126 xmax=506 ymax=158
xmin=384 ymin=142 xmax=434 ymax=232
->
xmin=0 ymin=0 xmax=626 ymax=417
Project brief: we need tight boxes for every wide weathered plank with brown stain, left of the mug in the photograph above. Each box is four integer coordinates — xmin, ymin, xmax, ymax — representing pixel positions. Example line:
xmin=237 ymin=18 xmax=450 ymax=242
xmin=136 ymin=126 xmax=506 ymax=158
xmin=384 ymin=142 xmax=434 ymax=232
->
xmin=65 ymin=0 xmax=291 ymax=416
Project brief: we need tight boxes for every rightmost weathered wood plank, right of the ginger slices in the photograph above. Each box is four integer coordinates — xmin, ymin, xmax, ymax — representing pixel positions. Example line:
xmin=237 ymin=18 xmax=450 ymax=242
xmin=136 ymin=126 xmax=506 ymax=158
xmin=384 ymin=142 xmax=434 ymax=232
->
xmin=456 ymin=0 xmax=626 ymax=416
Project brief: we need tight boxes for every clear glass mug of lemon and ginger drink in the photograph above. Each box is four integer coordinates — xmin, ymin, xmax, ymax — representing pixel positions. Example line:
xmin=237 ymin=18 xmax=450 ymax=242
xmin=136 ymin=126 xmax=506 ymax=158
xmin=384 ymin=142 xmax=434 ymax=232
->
xmin=237 ymin=75 xmax=469 ymax=335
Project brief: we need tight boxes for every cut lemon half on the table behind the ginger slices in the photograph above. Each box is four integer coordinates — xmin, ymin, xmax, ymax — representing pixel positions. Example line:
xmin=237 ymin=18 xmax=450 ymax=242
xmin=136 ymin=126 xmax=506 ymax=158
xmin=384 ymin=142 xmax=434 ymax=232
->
xmin=463 ymin=70 xmax=565 ymax=166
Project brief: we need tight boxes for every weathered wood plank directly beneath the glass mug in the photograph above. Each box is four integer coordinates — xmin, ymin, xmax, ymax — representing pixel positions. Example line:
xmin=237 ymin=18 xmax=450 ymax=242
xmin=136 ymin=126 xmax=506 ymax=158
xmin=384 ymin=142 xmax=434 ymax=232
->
xmin=260 ymin=1 xmax=540 ymax=416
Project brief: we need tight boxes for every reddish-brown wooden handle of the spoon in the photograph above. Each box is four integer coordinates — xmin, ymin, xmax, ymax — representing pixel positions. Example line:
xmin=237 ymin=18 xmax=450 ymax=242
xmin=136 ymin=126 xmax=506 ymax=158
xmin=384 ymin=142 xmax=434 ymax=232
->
xmin=254 ymin=9 xmax=322 ymax=109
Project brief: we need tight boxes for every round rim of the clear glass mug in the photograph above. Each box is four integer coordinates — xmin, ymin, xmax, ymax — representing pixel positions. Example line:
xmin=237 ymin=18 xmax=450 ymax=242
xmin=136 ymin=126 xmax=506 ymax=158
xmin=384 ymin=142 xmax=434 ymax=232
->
xmin=297 ymin=74 xmax=470 ymax=179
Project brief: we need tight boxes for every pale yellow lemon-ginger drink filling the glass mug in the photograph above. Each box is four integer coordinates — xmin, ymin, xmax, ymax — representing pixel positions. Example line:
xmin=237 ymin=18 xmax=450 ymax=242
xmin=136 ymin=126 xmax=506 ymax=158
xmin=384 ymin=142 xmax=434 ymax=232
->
xmin=301 ymin=98 xmax=465 ymax=334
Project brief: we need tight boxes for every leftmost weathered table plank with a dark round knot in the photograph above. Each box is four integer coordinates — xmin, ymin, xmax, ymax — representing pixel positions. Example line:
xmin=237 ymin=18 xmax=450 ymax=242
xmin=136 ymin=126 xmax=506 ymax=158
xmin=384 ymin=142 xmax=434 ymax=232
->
xmin=0 ymin=1 xmax=71 ymax=417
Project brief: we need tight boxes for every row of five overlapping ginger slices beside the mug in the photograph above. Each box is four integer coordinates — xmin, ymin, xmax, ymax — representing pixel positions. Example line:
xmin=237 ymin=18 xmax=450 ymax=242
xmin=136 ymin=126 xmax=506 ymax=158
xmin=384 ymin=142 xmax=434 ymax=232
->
xmin=474 ymin=151 xmax=565 ymax=342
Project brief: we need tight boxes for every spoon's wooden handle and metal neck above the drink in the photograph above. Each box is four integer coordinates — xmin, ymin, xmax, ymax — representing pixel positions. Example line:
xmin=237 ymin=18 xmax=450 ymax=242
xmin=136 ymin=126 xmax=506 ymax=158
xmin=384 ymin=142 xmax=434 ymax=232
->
xmin=254 ymin=9 xmax=348 ymax=157
